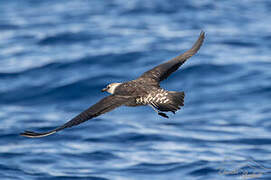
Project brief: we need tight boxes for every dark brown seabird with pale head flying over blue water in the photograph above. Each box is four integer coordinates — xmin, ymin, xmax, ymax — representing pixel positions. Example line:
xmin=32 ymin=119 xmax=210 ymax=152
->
xmin=20 ymin=31 xmax=205 ymax=138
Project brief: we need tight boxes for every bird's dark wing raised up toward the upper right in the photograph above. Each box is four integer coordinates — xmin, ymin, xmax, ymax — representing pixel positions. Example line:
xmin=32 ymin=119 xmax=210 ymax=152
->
xmin=138 ymin=31 xmax=205 ymax=82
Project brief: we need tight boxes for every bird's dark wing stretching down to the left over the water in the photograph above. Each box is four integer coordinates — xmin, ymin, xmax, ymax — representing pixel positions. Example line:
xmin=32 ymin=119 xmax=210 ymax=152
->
xmin=20 ymin=95 xmax=131 ymax=138
